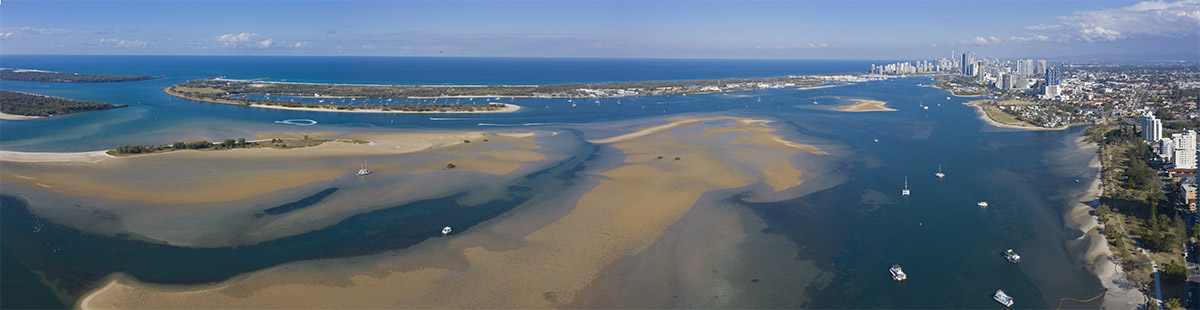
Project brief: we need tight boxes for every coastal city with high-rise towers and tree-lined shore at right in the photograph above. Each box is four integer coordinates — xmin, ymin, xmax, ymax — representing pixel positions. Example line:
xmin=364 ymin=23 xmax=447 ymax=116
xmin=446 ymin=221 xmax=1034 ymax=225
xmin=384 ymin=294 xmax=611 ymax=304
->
xmin=871 ymin=53 xmax=1200 ymax=309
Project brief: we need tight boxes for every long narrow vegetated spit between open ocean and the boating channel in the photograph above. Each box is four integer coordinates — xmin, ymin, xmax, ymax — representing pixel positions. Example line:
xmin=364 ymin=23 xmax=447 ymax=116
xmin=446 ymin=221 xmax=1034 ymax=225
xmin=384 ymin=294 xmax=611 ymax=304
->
xmin=163 ymin=76 xmax=841 ymax=113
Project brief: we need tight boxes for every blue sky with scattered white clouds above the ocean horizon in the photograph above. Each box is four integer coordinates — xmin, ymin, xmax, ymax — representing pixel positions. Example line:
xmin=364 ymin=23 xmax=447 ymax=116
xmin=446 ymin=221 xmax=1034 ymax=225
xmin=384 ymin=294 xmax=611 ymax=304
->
xmin=0 ymin=0 xmax=1200 ymax=60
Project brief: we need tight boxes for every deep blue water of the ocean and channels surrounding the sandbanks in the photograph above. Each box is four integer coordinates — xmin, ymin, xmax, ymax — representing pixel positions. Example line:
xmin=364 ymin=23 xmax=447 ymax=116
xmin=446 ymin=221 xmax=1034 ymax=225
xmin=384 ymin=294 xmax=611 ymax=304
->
xmin=0 ymin=55 xmax=1102 ymax=309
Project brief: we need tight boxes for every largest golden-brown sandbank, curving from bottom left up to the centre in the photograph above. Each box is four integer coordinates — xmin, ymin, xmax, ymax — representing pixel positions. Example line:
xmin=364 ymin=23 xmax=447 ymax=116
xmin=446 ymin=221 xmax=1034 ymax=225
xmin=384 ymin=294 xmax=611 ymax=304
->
xmin=79 ymin=119 xmax=830 ymax=309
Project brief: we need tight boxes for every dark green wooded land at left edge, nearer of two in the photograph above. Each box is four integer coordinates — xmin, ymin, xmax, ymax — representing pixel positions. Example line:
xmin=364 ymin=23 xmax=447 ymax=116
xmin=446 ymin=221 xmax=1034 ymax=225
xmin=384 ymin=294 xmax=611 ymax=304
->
xmin=0 ymin=90 xmax=125 ymax=117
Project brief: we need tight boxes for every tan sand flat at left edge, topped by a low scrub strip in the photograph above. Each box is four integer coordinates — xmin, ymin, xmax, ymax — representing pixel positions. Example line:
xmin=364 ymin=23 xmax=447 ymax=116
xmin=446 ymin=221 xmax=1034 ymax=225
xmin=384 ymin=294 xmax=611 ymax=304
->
xmin=0 ymin=132 xmax=545 ymax=203
